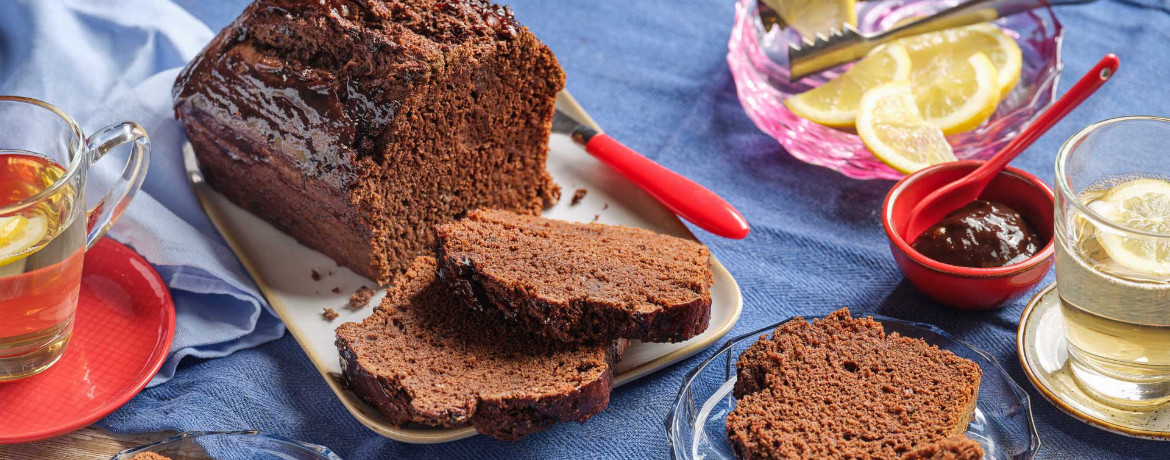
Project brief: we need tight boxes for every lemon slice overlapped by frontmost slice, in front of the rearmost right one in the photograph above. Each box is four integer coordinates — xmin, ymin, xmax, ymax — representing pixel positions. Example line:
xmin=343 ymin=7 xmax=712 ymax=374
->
xmin=910 ymin=53 xmax=999 ymax=136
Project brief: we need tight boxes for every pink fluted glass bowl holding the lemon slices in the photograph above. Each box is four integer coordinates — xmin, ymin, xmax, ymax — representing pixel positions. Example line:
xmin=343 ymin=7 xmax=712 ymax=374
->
xmin=728 ymin=0 xmax=1064 ymax=179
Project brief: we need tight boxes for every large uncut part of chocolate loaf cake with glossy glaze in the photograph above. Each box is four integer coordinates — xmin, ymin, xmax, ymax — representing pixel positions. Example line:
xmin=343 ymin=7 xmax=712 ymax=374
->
xmin=173 ymin=0 xmax=565 ymax=284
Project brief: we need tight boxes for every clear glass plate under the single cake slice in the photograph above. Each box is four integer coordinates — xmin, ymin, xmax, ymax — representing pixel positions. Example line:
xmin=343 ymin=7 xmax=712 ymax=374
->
xmin=666 ymin=314 xmax=1040 ymax=460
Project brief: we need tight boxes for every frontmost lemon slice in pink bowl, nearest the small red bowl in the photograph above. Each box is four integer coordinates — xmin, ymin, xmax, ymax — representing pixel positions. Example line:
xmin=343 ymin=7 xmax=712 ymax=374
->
xmin=858 ymin=81 xmax=956 ymax=174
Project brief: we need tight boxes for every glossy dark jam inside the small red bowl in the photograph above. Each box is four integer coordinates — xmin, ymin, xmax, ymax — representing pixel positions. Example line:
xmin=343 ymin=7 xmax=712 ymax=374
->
xmin=911 ymin=200 xmax=1042 ymax=268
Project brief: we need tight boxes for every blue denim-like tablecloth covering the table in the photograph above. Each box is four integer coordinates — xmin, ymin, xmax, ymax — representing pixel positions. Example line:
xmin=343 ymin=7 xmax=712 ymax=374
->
xmin=88 ymin=0 xmax=1170 ymax=459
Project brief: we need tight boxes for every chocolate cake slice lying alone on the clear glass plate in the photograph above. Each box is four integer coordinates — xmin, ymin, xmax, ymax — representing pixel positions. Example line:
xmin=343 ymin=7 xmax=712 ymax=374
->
xmin=727 ymin=308 xmax=982 ymax=459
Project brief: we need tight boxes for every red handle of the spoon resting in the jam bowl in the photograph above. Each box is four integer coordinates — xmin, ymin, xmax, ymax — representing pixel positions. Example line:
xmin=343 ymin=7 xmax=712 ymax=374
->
xmin=971 ymin=53 xmax=1121 ymax=184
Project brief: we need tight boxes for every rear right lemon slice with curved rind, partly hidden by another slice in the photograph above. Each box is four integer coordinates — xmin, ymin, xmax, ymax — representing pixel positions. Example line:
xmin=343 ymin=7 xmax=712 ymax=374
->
xmin=900 ymin=23 xmax=1024 ymax=99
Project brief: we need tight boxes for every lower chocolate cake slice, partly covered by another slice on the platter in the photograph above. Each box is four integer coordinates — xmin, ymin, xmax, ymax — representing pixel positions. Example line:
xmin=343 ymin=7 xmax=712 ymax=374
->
xmin=337 ymin=256 xmax=626 ymax=439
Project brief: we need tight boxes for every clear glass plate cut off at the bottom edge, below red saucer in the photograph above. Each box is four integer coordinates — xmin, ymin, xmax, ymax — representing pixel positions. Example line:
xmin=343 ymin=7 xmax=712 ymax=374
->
xmin=110 ymin=431 xmax=342 ymax=460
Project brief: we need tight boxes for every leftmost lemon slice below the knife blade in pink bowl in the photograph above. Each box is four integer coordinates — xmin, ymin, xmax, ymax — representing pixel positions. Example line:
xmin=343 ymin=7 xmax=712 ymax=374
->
xmin=784 ymin=43 xmax=910 ymax=128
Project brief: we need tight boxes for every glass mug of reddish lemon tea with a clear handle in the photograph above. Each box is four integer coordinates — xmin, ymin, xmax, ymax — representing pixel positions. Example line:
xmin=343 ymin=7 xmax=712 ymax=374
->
xmin=0 ymin=96 xmax=150 ymax=382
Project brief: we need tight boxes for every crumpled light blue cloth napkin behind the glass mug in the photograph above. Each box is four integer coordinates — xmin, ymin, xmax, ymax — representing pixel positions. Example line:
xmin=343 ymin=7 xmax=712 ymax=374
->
xmin=0 ymin=0 xmax=284 ymax=385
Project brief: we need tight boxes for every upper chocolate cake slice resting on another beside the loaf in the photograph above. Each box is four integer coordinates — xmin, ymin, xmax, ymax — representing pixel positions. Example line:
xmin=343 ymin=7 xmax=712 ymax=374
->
xmin=435 ymin=210 xmax=711 ymax=342
